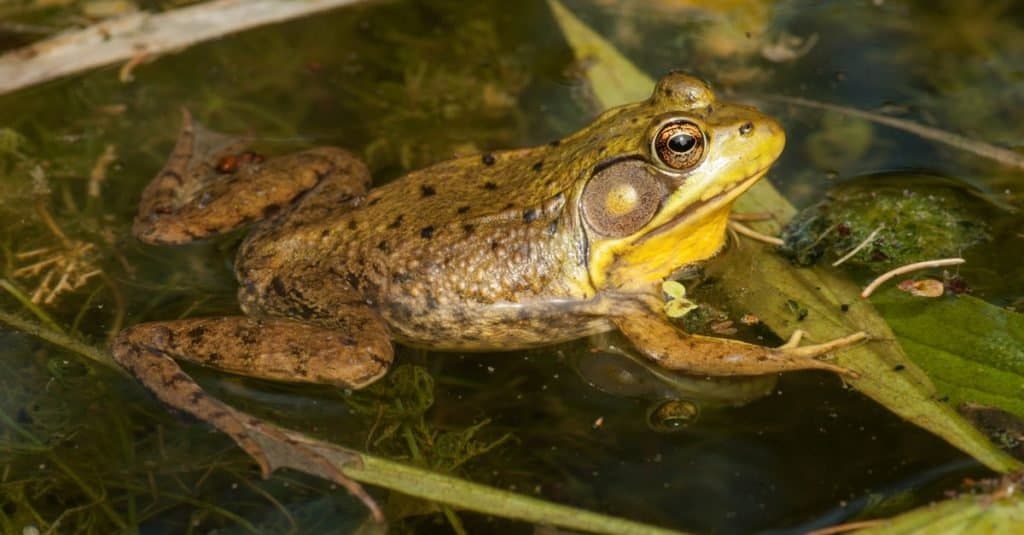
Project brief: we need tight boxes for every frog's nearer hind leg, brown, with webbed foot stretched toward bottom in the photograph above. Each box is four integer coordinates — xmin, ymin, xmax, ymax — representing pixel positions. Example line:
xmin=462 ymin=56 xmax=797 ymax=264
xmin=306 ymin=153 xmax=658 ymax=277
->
xmin=113 ymin=310 xmax=392 ymax=520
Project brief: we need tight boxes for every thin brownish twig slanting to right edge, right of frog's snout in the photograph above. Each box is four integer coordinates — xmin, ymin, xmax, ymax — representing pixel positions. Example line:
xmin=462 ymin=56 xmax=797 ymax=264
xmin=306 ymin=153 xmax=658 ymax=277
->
xmin=762 ymin=95 xmax=1024 ymax=169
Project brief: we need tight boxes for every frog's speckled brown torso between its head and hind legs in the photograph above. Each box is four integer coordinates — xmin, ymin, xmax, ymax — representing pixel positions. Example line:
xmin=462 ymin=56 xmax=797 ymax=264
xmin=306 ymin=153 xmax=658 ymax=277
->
xmin=237 ymin=149 xmax=598 ymax=347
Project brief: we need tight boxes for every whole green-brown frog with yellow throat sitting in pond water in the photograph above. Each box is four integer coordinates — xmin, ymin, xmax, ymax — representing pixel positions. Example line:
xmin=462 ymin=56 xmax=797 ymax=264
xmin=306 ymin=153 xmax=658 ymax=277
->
xmin=112 ymin=72 xmax=867 ymax=510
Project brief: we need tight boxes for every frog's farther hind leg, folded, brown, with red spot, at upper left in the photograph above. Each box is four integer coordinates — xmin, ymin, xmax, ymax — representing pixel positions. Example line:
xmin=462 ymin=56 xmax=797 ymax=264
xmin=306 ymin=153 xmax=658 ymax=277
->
xmin=132 ymin=110 xmax=370 ymax=244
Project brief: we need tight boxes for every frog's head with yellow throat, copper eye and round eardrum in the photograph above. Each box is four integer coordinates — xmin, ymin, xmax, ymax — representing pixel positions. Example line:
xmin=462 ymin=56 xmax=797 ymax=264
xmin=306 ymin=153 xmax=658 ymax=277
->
xmin=567 ymin=73 xmax=785 ymax=290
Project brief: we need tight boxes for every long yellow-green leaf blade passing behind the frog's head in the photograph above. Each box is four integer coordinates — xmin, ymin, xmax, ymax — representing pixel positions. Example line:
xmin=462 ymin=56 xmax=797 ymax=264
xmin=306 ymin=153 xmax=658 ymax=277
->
xmin=548 ymin=0 xmax=1021 ymax=471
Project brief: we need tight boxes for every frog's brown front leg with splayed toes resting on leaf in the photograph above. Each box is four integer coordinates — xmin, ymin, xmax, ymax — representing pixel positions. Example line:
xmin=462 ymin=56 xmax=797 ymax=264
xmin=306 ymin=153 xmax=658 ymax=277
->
xmin=612 ymin=297 xmax=867 ymax=376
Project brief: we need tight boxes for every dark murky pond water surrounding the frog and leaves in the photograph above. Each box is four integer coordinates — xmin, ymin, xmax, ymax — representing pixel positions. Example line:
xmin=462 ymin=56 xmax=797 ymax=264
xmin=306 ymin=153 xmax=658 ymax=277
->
xmin=0 ymin=0 xmax=1024 ymax=533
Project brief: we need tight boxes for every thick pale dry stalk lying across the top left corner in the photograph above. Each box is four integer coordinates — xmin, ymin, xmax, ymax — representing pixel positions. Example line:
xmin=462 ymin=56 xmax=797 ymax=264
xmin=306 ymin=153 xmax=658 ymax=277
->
xmin=0 ymin=0 xmax=374 ymax=93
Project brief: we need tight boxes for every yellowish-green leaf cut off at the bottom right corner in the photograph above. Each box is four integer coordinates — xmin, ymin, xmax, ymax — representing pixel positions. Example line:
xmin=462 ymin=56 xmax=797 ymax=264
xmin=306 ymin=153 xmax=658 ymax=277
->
xmin=857 ymin=494 xmax=1024 ymax=535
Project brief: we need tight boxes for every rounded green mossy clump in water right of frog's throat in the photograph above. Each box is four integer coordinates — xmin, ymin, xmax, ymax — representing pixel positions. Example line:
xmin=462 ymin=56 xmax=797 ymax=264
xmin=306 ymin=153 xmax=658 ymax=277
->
xmin=782 ymin=177 xmax=990 ymax=273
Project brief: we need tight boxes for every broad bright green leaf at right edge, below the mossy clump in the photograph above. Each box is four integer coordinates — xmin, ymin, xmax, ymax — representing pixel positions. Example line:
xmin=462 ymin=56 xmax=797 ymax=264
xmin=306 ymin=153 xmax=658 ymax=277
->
xmin=871 ymin=289 xmax=1024 ymax=417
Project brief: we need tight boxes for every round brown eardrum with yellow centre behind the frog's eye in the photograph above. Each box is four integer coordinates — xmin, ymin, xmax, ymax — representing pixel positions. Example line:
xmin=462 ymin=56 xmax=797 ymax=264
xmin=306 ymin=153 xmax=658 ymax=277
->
xmin=582 ymin=160 xmax=663 ymax=238
